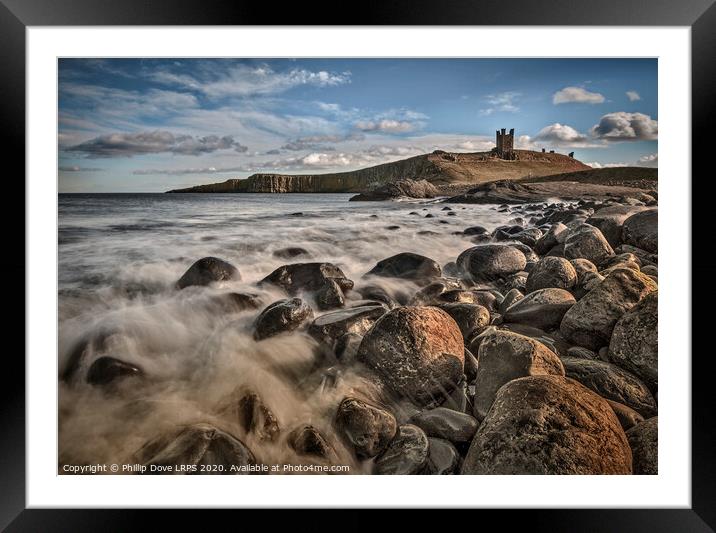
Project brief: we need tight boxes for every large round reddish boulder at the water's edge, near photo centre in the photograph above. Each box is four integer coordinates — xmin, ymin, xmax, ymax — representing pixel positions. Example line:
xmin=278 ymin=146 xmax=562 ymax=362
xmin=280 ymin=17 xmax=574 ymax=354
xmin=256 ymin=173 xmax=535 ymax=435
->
xmin=357 ymin=307 xmax=465 ymax=405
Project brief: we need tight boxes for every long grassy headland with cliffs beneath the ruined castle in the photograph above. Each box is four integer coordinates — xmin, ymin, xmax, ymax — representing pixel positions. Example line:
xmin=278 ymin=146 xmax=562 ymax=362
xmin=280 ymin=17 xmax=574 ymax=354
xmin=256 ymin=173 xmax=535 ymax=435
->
xmin=168 ymin=150 xmax=591 ymax=193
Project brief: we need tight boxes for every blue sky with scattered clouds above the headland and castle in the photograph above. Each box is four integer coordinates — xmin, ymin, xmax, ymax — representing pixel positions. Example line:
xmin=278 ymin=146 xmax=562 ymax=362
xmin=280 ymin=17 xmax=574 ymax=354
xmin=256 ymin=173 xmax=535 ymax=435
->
xmin=58 ymin=58 xmax=658 ymax=192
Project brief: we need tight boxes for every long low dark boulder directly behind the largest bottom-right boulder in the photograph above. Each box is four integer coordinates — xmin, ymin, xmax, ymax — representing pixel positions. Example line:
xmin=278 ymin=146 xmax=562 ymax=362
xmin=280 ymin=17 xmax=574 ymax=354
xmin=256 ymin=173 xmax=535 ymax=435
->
xmin=562 ymin=357 xmax=657 ymax=418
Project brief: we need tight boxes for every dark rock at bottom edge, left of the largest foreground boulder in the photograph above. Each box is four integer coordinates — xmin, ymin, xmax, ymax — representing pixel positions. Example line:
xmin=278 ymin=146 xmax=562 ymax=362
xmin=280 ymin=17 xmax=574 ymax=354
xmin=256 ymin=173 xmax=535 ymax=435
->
xmin=374 ymin=424 xmax=429 ymax=475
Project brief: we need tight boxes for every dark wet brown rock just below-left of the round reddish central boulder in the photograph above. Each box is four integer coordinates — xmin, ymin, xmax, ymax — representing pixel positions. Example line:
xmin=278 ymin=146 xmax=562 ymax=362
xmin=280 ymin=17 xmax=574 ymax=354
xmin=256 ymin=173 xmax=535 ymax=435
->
xmin=335 ymin=398 xmax=398 ymax=458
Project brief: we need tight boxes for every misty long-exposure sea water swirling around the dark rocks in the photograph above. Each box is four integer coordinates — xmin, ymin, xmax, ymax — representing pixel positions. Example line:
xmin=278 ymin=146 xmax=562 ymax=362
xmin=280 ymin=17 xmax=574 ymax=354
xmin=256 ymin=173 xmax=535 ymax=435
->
xmin=58 ymin=194 xmax=513 ymax=473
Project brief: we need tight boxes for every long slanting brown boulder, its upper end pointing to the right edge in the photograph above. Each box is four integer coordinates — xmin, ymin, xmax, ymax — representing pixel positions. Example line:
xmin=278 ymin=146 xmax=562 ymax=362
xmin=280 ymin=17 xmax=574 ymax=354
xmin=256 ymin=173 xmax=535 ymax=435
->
xmin=560 ymin=268 xmax=657 ymax=351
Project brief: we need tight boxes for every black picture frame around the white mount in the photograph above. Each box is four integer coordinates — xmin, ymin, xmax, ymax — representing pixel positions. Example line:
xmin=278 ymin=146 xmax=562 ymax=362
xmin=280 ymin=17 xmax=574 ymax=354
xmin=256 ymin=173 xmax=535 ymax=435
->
xmin=0 ymin=0 xmax=716 ymax=531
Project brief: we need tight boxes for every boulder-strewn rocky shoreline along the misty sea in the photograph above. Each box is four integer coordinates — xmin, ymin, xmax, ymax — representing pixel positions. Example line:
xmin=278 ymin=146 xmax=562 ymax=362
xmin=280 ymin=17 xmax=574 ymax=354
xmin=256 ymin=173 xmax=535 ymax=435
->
xmin=62 ymin=189 xmax=658 ymax=475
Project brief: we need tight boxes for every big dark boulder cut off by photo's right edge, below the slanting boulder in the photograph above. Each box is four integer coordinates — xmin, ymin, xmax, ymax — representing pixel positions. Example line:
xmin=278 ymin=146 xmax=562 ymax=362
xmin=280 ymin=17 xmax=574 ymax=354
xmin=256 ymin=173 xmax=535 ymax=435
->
xmin=609 ymin=291 xmax=659 ymax=390
